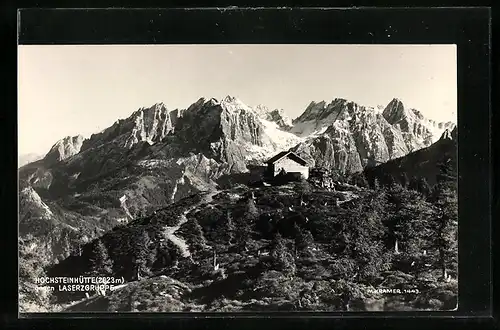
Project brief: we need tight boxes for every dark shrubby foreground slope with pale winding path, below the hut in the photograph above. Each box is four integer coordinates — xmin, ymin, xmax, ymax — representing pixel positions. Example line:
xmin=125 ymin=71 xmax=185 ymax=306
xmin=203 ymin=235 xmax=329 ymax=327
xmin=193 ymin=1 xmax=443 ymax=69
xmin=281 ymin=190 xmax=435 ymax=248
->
xmin=41 ymin=178 xmax=457 ymax=311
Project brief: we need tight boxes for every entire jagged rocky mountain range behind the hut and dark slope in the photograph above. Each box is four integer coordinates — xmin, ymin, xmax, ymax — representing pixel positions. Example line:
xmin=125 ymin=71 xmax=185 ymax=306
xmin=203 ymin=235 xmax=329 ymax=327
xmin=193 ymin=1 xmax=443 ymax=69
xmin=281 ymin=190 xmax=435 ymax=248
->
xmin=19 ymin=96 xmax=456 ymax=261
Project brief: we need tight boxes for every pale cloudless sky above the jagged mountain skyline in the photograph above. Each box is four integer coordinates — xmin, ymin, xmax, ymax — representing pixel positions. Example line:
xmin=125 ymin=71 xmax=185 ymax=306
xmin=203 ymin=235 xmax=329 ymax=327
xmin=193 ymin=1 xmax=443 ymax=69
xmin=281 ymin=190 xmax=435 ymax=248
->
xmin=18 ymin=45 xmax=457 ymax=154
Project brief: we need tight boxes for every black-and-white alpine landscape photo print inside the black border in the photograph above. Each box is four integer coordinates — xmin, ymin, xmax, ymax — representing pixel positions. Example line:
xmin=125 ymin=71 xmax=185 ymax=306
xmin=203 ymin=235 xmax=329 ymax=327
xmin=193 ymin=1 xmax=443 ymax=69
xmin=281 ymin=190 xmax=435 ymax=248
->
xmin=17 ymin=44 xmax=460 ymax=313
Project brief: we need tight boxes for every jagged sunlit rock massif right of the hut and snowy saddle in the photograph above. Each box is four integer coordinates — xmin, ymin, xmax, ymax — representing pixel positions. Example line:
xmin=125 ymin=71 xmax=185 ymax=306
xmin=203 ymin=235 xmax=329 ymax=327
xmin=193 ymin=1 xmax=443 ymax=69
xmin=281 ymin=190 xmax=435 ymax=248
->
xmin=289 ymin=99 xmax=454 ymax=173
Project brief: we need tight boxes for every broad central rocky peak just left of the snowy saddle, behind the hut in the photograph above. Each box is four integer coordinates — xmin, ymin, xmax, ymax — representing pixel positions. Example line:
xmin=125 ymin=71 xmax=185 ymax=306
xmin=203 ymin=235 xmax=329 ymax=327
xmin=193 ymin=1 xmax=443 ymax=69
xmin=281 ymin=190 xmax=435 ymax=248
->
xmin=170 ymin=96 xmax=298 ymax=171
